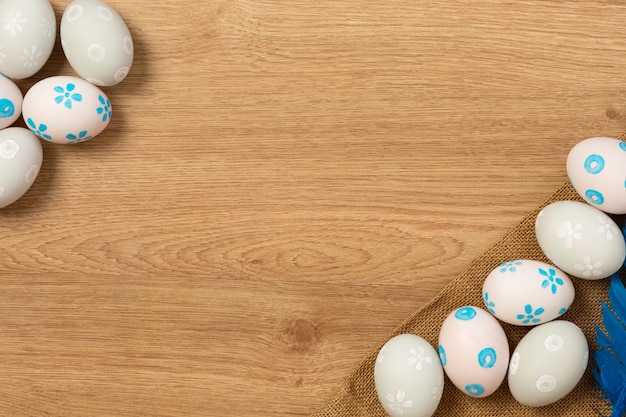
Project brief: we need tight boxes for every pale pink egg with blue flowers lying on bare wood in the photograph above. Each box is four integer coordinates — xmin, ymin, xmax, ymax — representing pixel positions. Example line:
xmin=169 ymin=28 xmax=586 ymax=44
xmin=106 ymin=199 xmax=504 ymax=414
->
xmin=22 ymin=76 xmax=112 ymax=144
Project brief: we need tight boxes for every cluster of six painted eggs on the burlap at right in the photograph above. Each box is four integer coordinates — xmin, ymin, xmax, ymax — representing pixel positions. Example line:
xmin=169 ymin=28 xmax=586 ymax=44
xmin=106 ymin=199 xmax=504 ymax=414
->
xmin=374 ymin=137 xmax=626 ymax=417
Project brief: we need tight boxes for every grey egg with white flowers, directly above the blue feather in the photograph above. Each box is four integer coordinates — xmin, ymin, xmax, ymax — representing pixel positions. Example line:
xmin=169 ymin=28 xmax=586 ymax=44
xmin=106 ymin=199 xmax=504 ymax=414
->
xmin=535 ymin=201 xmax=626 ymax=279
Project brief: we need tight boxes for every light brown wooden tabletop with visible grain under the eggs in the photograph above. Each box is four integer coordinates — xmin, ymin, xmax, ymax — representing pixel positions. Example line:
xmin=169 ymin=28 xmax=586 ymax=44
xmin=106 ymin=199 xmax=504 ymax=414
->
xmin=0 ymin=0 xmax=626 ymax=417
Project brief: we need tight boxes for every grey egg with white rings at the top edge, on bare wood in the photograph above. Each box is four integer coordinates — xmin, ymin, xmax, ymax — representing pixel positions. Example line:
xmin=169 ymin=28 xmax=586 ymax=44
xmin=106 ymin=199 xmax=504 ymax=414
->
xmin=61 ymin=0 xmax=134 ymax=86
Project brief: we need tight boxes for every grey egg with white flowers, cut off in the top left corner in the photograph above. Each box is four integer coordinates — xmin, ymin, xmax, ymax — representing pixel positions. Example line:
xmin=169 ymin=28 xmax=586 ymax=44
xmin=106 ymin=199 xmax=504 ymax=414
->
xmin=0 ymin=0 xmax=57 ymax=79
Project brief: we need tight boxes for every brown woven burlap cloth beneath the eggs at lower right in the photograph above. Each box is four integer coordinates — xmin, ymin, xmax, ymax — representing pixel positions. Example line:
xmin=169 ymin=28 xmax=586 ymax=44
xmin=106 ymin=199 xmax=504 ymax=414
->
xmin=310 ymin=133 xmax=626 ymax=417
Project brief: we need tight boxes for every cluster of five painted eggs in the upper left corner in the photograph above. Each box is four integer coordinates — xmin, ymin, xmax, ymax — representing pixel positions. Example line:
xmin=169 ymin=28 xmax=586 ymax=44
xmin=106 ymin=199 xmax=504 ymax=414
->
xmin=0 ymin=0 xmax=134 ymax=208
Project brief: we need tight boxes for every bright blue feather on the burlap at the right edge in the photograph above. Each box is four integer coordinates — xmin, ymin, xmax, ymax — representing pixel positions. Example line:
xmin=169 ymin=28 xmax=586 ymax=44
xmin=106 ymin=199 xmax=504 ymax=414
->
xmin=593 ymin=275 xmax=626 ymax=417
